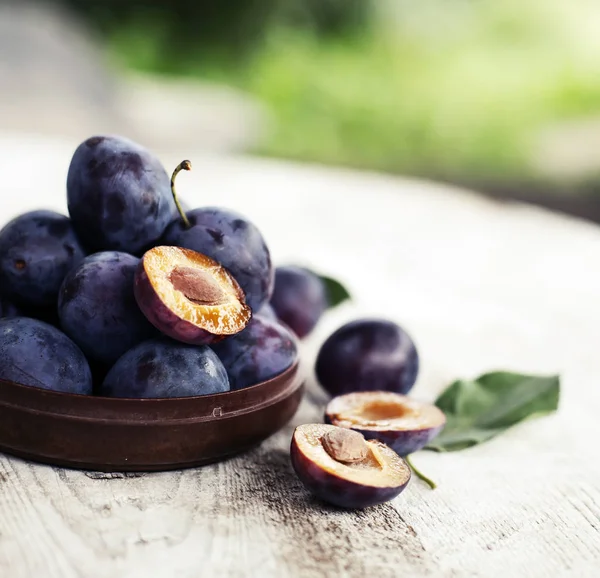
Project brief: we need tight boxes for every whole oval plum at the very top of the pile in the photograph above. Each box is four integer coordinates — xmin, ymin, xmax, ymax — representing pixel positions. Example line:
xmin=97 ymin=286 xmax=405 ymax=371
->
xmin=67 ymin=135 xmax=176 ymax=255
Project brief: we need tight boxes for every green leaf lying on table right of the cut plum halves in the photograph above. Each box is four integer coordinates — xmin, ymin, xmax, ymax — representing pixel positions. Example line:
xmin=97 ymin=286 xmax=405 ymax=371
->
xmin=425 ymin=371 xmax=560 ymax=452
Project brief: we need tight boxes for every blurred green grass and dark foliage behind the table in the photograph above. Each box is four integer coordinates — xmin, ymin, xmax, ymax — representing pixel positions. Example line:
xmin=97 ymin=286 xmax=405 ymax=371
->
xmin=59 ymin=0 xmax=600 ymax=217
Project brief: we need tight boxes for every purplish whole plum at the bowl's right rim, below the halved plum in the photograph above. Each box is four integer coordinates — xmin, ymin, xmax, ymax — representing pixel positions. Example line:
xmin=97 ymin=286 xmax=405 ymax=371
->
xmin=212 ymin=317 xmax=298 ymax=389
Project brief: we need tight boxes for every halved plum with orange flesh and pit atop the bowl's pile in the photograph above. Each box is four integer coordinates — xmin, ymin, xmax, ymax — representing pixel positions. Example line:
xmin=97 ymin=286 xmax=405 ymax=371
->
xmin=134 ymin=246 xmax=251 ymax=345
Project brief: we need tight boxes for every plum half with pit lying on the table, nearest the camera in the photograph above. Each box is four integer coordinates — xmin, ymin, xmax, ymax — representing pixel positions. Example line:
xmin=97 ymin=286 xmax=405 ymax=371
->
xmin=291 ymin=424 xmax=411 ymax=509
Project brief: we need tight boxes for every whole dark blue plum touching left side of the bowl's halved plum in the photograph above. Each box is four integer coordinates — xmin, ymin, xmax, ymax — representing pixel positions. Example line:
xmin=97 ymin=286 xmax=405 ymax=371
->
xmin=58 ymin=251 xmax=157 ymax=364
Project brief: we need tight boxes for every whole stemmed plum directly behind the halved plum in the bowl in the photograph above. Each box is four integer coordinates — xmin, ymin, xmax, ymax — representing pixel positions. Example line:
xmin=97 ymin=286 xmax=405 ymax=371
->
xmin=162 ymin=207 xmax=273 ymax=311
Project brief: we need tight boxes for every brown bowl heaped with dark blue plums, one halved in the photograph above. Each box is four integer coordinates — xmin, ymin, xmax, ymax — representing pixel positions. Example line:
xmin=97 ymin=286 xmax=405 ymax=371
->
xmin=0 ymin=135 xmax=303 ymax=471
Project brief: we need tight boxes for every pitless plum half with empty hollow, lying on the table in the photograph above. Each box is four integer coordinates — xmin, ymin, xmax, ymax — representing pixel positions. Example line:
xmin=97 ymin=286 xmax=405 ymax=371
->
xmin=325 ymin=391 xmax=446 ymax=456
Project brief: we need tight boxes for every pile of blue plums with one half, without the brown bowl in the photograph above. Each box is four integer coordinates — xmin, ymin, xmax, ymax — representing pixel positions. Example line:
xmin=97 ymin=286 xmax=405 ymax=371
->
xmin=0 ymin=136 xmax=300 ymax=398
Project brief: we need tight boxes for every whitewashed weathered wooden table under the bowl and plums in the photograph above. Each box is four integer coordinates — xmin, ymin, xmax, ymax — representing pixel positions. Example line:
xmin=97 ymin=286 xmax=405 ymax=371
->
xmin=0 ymin=135 xmax=600 ymax=578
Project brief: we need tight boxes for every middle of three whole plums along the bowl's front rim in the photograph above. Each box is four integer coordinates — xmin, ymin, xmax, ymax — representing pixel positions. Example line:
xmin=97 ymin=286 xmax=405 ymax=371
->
xmin=100 ymin=337 xmax=229 ymax=398
